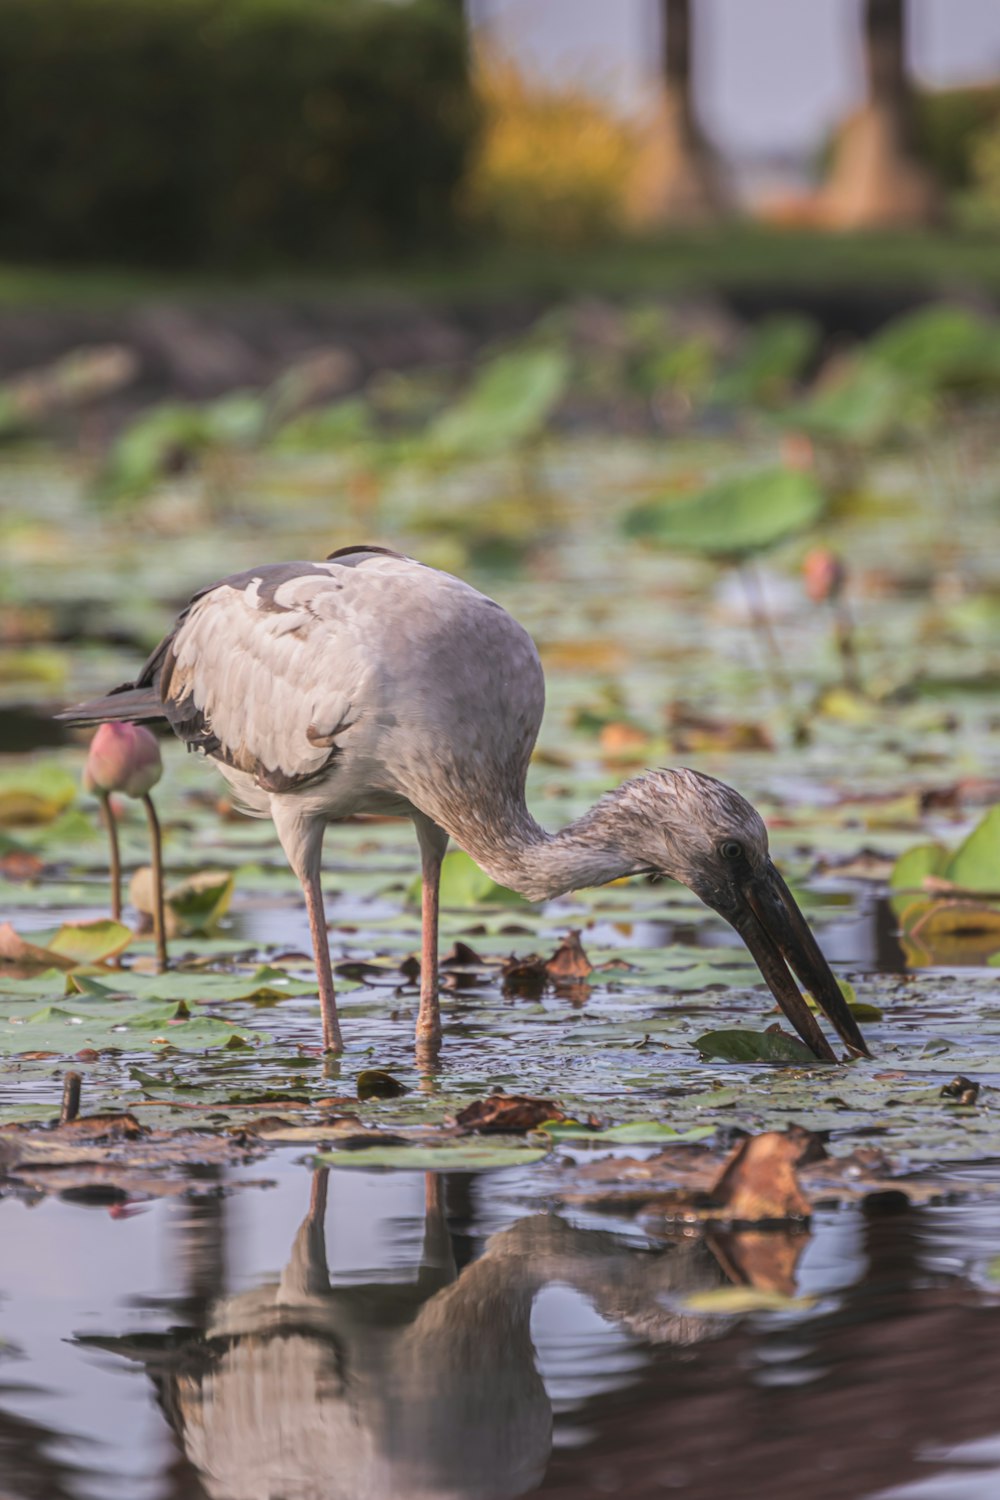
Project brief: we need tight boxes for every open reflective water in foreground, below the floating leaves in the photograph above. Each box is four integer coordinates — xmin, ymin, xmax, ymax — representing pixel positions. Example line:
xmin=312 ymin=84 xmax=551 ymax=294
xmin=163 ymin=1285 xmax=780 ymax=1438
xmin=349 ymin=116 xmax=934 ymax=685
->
xmin=0 ymin=1152 xmax=1000 ymax=1500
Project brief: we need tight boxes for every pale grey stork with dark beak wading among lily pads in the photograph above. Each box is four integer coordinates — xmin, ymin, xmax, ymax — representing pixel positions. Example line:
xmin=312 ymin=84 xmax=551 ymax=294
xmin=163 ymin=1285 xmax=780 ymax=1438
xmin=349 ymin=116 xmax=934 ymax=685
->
xmin=60 ymin=546 xmax=868 ymax=1061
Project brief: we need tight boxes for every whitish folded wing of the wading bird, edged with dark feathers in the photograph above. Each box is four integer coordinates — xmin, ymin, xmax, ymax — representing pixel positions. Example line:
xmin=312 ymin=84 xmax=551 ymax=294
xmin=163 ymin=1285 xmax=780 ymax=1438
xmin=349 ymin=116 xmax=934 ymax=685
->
xmin=148 ymin=563 xmax=379 ymax=792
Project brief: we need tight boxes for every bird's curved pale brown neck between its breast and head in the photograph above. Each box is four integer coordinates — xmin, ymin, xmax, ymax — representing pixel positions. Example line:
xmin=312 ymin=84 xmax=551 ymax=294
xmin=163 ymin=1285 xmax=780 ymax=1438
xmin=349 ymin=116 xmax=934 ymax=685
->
xmin=442 ymin=803 xmax=642 ymax=902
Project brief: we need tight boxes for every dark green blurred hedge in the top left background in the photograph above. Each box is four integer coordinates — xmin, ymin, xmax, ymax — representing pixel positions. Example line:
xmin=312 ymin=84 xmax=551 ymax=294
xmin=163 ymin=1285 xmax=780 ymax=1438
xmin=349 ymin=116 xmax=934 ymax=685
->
xmin=0 ymin=0 xmax=477 ymax=267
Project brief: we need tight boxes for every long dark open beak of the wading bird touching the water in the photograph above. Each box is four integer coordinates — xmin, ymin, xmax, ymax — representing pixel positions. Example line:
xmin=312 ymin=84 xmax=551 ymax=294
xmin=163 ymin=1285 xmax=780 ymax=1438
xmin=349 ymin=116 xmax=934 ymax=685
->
xmin=726 ymin=861 xmax=871 ymax=1062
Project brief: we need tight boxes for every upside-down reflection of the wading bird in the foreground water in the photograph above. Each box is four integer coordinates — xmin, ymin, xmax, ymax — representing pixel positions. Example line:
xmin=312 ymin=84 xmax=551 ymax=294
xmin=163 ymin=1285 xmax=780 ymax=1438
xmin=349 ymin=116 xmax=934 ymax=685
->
xmin=88 ymin=1170 xmax=807 ymax=1500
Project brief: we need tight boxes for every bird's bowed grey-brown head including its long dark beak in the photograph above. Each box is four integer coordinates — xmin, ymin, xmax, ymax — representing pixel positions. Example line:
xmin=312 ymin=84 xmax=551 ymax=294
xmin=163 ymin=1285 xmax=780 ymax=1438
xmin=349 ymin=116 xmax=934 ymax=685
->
xmin=602 ymin=770 xmax=870 ymax=1061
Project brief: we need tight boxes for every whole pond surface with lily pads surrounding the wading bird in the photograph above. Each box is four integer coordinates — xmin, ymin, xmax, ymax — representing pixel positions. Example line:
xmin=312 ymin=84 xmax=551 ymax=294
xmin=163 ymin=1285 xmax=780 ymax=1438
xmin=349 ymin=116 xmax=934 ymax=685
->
xmin=0 ymin=375 xmax=1000 ymax=1500
